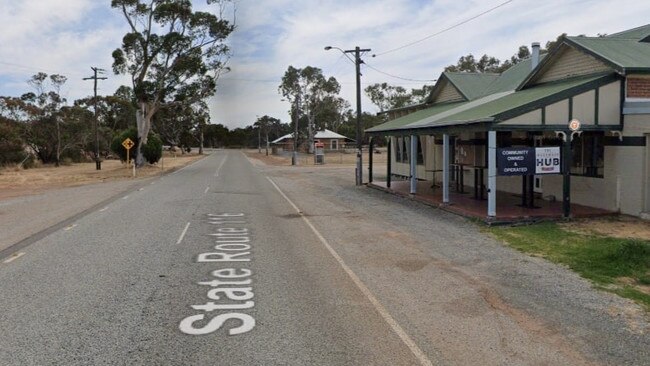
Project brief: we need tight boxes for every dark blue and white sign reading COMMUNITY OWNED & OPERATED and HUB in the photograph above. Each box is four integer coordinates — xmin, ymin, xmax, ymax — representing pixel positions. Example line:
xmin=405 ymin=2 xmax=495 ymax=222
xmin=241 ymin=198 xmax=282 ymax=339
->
xmin=497 ymin=147 xmax=561 ymax=175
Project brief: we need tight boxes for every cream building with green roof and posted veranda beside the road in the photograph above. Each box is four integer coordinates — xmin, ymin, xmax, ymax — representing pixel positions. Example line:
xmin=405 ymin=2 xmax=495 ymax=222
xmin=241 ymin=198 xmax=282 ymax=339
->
xmin=365 ymin=25 xmax=650 ymax=220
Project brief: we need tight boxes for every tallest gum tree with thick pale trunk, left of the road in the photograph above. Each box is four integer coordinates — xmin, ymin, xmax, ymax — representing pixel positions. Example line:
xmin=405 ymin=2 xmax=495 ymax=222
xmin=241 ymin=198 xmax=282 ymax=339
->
xmin=111 ymin=0 xmax=234 ymax=167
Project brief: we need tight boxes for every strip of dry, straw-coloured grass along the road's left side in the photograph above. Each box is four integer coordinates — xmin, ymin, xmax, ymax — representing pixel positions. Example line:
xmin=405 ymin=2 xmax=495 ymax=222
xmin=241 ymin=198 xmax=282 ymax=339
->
xmin=0 ymin=153 xmax=202 ymax=200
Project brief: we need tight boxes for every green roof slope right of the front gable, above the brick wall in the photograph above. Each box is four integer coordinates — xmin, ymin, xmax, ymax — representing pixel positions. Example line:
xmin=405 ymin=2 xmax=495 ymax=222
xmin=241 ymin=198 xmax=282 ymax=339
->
xmin=567 ymin=37 xmax=650 ymax=69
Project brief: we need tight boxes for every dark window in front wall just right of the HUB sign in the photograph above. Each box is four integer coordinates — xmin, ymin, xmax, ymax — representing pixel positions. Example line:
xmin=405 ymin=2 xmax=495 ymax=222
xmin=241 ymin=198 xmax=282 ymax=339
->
xmin=571 ymin=132 xmax=605 ymax=178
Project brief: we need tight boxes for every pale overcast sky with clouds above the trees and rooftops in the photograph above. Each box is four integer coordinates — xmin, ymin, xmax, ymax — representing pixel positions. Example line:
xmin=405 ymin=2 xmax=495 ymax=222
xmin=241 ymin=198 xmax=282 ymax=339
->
xmin=0 ymin=0 xmax=650 ymax=128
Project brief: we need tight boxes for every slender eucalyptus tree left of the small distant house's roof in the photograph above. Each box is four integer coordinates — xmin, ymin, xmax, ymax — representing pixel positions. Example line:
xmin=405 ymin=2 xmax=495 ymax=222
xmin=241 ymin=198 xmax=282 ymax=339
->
xmin=278 ymin=66 xmax=341 ymax=152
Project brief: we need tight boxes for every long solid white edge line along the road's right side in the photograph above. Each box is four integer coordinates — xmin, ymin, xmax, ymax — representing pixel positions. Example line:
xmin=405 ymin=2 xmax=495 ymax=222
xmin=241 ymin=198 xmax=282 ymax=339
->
xmin=266 ymin=177 xmax=433 ymax=366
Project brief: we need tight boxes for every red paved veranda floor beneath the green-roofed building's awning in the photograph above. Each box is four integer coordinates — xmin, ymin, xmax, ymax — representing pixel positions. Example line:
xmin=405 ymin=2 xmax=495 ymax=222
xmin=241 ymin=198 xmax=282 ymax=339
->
xmin=369 ymin=180 xmax=616 ymax=222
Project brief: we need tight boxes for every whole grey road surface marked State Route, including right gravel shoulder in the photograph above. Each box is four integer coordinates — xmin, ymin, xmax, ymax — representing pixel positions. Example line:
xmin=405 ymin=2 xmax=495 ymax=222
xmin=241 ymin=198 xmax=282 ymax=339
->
xmin=0 ymin=151 xmax=650 ymax=365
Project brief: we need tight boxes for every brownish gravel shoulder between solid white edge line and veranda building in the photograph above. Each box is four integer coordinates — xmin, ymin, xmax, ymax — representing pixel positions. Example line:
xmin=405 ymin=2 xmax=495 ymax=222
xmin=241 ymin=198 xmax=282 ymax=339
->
xmin=258 ymin=160 xmax=650 ymax=365
